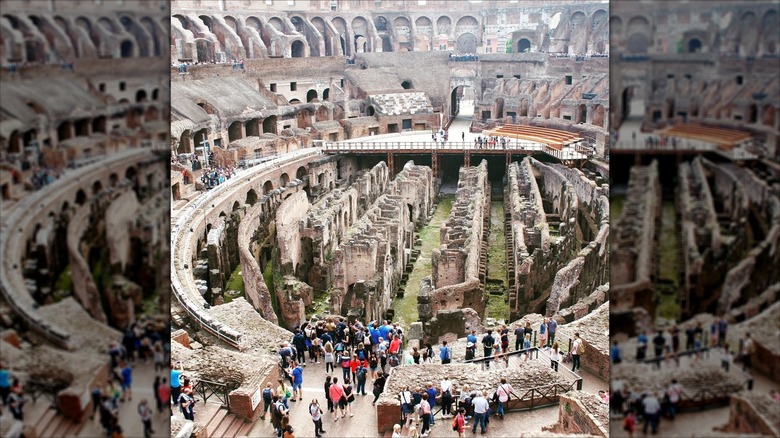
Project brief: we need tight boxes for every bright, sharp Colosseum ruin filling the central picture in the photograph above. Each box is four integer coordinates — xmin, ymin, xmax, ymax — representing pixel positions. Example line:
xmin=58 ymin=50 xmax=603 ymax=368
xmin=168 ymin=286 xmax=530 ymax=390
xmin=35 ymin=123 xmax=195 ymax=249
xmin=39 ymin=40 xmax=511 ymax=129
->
xmin=170 ymin=0 xmax=609 ymax=436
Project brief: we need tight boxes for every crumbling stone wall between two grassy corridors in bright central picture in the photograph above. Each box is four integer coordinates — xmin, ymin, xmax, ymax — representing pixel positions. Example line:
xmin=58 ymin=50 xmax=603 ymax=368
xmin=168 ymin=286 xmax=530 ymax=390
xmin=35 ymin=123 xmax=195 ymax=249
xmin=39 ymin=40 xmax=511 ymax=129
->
xmin=417 ymin=160 xmax=490 ymax=335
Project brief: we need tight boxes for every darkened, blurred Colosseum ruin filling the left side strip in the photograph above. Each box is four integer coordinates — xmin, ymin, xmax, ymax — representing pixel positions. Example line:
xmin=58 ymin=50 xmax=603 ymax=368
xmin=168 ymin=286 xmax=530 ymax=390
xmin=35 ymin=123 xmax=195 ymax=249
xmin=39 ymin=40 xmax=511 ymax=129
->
xmin=0 ymin=0 xmax=170 ymax=437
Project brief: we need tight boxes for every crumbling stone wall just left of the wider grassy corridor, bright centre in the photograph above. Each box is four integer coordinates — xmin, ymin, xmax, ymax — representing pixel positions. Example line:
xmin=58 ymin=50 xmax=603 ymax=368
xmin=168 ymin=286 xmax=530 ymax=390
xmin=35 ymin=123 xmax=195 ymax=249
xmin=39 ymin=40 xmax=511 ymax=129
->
xmin=331 ymin=162 xmax=433 ymax=320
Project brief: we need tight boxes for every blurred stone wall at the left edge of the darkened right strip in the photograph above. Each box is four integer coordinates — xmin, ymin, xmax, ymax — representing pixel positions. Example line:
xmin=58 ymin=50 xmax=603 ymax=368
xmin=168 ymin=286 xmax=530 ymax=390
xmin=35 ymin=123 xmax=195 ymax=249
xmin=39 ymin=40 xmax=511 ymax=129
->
xmin=610 ymin=161 xmax=661 ymax=335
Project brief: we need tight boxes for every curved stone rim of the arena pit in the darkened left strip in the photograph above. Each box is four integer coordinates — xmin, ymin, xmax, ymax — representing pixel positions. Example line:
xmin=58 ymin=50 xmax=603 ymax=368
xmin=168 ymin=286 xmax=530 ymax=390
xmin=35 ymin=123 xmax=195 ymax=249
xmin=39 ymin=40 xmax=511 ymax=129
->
xmin=0 ymin=148 xmax=149 ymax=349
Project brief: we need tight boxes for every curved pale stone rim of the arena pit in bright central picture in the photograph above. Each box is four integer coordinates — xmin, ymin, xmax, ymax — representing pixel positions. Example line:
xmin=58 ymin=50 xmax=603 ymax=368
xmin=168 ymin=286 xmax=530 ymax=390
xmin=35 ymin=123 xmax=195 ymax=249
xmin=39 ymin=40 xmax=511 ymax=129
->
xmin=171 ymin=148 xmax=321 ymax=349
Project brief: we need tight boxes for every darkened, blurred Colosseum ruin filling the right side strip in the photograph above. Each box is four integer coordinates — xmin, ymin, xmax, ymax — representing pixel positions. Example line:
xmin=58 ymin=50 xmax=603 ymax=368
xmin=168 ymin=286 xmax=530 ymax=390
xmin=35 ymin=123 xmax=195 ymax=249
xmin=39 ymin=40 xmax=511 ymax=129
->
xmin=610 ymin=1 xmax=780 ymax=436
